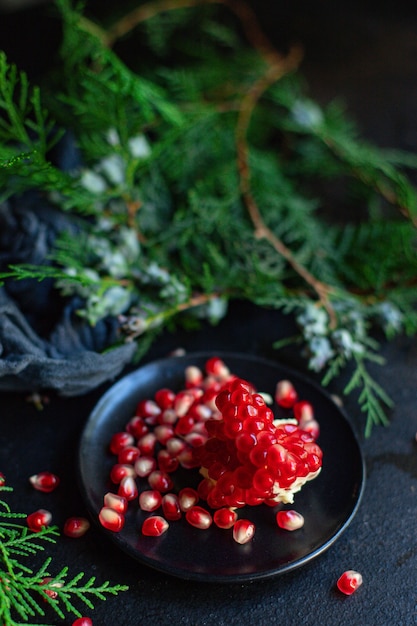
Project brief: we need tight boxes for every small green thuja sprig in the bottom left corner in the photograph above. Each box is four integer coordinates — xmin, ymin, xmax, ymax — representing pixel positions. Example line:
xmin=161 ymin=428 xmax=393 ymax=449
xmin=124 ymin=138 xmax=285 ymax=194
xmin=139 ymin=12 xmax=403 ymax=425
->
xmin=0 ymin=485 xmax=127 ymax=626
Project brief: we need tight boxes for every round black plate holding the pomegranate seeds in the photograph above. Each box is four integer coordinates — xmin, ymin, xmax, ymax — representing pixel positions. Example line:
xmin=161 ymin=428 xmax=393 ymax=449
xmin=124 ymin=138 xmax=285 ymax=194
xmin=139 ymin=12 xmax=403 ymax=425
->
xmin=79 ymin=353 xmax=365 ymax=582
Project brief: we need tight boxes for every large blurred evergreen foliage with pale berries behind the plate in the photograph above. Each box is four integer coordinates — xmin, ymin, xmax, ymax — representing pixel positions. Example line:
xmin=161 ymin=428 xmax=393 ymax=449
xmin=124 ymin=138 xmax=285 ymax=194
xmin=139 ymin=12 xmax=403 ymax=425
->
xmin=0 ymin=0 xmax=417 ymax=435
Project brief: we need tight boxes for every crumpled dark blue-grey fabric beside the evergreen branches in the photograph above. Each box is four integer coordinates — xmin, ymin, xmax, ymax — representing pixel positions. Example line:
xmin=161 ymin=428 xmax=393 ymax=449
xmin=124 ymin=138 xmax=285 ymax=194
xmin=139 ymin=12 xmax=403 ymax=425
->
xmin=0 ymin=193 xmax=135 ymax=396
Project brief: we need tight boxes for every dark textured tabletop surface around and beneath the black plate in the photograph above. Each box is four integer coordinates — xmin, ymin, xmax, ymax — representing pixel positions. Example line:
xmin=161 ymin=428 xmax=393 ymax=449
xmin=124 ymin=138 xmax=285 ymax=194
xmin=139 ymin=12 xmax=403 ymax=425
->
xmin=0 ymin=0 xmax=417 ymax=626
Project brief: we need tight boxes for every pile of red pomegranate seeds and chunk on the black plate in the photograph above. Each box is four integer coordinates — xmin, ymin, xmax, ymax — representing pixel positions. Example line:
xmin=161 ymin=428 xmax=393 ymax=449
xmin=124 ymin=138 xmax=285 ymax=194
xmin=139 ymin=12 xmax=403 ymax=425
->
xmin=99 ymin=357 xmax=322 ymax=543
